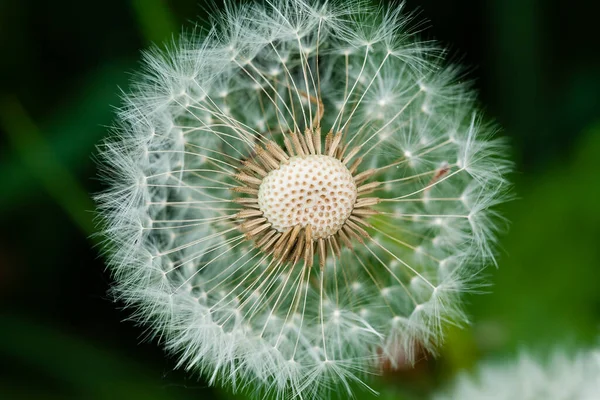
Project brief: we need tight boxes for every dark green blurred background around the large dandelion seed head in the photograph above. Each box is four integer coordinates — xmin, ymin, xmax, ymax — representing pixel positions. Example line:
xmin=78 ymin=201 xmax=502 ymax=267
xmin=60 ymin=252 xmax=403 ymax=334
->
xmin=0 ymin=0 xmax=600 ymax=400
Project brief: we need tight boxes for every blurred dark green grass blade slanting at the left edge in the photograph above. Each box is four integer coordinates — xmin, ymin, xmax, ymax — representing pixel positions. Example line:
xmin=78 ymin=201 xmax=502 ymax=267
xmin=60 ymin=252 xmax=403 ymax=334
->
xmin=0 ymin=97 xmax=95 ymax=235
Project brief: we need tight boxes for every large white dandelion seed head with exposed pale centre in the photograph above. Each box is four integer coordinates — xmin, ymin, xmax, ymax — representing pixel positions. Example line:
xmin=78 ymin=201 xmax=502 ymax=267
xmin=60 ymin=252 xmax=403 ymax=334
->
xmin=98 ymin=0 xmax=509 ymax=399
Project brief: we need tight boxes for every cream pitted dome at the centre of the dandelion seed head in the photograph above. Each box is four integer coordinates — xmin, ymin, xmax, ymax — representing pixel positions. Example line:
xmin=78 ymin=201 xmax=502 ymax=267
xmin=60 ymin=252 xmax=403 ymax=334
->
xmin=258 ymin=155 xmax=357 ymax=239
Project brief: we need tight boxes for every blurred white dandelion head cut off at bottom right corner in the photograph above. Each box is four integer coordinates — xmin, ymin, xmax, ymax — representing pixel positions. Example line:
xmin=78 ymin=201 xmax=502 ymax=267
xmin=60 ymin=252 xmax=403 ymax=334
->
xmin=433 ymin=349 xmax=600 ymax=400
